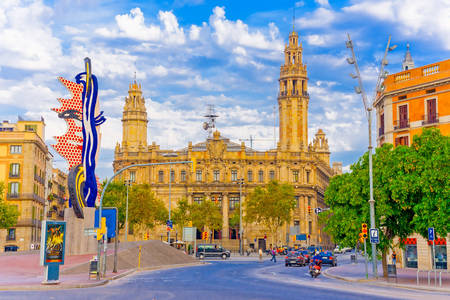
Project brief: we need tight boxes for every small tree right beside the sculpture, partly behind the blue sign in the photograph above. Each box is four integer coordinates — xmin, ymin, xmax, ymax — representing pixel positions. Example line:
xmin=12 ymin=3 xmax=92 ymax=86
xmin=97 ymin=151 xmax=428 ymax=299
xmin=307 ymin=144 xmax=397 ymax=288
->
xmin=103 ymin=181 xmax=127 ymax=229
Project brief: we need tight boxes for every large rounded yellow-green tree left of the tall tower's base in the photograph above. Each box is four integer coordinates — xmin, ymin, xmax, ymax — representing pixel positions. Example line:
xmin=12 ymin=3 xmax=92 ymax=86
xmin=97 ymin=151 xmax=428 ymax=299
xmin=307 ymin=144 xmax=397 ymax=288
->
xmin=244 ymin=181 xmax=296 ymax=245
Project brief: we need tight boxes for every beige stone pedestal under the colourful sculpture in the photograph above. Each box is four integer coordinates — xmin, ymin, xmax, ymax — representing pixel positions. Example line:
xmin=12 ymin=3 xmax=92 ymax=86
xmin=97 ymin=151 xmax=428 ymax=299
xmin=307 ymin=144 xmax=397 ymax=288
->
xmin=64 ymin=207 xmax=97 ymax=255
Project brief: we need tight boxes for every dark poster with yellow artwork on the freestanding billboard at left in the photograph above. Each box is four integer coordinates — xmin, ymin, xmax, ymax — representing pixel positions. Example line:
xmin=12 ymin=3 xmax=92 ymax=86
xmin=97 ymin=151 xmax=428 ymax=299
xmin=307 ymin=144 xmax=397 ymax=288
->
xmin=41 ymin=221 xmax=66 ymax=265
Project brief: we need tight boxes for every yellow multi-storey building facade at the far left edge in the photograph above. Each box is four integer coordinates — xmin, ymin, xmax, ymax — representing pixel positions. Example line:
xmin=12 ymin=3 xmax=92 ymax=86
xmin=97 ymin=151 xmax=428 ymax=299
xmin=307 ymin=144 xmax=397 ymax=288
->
xmin=0 ymin=118 xmax=48 ymax=252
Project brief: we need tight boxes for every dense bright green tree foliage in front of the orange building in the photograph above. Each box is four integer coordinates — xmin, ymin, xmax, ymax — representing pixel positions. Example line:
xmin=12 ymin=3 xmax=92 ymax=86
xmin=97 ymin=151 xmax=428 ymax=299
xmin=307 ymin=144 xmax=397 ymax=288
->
xmin=320 ymin=129 xmax=450 ymax=273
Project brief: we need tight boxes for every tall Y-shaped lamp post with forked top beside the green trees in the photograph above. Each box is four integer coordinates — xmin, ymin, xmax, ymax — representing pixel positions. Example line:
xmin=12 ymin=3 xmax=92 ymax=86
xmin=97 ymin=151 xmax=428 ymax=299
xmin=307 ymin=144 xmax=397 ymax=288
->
xmin=345 ymin=33 xmax=397 ymax=278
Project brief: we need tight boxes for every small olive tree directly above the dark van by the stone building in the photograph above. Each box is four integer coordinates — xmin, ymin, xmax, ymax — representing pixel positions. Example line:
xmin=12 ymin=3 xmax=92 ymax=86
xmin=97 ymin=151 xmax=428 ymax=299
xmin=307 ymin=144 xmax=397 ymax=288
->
xmin=190 ymin=199 xmax=222 ymax=240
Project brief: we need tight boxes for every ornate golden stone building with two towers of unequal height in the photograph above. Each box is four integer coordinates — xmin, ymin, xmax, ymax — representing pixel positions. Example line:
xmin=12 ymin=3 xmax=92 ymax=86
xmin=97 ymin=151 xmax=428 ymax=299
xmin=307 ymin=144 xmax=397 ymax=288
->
xmin=113 ymin=32 xmax=339 ymax=249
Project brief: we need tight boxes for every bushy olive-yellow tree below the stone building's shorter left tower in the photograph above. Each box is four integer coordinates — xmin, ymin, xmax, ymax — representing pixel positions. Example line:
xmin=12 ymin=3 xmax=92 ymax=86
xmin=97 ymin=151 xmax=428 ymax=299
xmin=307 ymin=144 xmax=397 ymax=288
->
xmin=128 ymin=184 xmax=169 ymax=229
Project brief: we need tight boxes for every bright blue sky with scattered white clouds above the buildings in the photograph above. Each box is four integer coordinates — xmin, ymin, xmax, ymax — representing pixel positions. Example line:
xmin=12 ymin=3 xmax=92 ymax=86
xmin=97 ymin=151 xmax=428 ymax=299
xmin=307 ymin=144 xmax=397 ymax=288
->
xmin=0 ymin=0 xmax=450 ymax=178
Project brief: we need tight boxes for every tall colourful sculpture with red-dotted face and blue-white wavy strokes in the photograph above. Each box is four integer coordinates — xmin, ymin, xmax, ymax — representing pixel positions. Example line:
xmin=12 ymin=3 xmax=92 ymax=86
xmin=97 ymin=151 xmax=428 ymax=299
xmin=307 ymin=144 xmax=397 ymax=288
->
xmin=52 ymin=58 xmax=106 ymax=218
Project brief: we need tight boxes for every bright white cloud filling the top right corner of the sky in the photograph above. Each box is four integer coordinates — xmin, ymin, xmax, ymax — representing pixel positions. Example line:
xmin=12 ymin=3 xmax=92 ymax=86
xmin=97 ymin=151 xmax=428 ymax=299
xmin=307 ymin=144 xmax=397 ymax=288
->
xmin=342 ymin=0 xmax=450 ymax=50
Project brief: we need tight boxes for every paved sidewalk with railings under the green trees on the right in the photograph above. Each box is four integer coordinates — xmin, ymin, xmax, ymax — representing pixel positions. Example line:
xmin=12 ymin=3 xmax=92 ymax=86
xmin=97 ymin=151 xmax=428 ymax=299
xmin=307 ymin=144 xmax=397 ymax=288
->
xmin=324 ymin=256 xmax=450 ymax=292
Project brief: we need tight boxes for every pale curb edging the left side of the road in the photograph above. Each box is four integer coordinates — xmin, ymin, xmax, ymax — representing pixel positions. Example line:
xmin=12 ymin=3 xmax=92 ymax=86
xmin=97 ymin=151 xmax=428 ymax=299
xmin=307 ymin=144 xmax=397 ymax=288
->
xmin=0 ymin=262 xmax=202 ymax=291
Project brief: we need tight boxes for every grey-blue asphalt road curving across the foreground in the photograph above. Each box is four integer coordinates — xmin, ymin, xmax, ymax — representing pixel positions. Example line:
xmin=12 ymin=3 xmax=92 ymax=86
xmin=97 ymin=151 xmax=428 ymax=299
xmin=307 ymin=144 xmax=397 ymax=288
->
xmin=0 ymin=258 xmax=448 ymax=300
